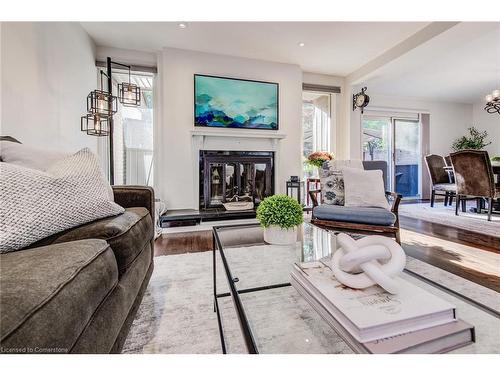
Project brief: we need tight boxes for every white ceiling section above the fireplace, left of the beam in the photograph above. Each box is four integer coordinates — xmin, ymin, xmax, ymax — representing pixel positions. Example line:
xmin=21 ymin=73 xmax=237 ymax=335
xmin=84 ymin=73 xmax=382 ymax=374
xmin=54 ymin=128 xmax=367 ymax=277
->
xmin=82 ymin=22 xmax=428 ymax=76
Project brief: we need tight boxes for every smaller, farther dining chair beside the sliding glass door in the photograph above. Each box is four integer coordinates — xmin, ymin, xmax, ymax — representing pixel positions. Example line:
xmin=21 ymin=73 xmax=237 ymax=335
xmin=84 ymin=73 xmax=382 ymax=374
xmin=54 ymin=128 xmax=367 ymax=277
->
xmin=425 ymin=154 xmax=457 ymax=207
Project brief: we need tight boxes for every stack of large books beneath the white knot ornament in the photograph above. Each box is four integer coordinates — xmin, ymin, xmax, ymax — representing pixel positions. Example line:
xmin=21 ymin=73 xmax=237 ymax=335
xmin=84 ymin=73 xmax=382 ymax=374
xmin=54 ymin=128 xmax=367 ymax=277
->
xmin=291 ymin=262 xmax=474 ymax=354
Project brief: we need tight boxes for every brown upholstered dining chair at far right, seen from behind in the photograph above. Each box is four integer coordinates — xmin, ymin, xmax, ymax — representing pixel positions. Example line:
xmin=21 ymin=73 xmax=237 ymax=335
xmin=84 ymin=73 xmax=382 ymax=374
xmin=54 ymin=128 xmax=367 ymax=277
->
xmin=450 ymin=150 xmax=500 ymax=221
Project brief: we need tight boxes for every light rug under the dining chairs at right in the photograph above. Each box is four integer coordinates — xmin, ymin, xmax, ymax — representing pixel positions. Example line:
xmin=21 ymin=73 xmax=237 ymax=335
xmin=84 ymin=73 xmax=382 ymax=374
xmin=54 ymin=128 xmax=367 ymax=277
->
xmin=399 ymin=202 xmax=500 ymax=237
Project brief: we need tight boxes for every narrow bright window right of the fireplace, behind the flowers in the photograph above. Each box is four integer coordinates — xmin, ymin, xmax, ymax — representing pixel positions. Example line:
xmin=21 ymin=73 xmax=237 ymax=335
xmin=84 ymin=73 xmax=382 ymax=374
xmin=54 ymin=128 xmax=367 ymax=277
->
xmin=302 ymin=91 xmax=333 ymax=179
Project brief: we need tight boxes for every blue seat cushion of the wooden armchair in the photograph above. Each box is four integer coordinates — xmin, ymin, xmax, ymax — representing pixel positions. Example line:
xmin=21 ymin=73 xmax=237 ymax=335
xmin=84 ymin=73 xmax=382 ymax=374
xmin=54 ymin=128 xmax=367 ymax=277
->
xmin=313 ymin=204 xmax=396 ymax=226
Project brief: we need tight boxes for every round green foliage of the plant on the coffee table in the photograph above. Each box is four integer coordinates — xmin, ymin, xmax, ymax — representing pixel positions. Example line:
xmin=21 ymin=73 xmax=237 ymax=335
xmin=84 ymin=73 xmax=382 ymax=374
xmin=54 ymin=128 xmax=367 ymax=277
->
xmin=257 ymin=194 xmax=304 ymax=229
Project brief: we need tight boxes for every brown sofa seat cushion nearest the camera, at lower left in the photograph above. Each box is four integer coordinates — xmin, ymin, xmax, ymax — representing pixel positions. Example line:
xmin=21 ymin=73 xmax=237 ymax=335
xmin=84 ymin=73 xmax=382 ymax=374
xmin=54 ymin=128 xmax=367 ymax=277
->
xmin=0 ymin=239 xmax=118 ymax=353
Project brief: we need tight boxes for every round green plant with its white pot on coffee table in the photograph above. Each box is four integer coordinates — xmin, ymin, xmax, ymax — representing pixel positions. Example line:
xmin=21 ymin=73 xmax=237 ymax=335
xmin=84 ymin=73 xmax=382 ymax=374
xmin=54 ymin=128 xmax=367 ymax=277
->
xmin=257 ymin=194 xmax=304 ymax=245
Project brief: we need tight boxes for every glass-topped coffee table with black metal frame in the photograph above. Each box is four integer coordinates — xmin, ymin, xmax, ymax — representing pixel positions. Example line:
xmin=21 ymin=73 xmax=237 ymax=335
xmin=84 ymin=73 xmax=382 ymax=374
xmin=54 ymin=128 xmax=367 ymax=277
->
xmin=212 ymin=223 xmax=500 ymax=354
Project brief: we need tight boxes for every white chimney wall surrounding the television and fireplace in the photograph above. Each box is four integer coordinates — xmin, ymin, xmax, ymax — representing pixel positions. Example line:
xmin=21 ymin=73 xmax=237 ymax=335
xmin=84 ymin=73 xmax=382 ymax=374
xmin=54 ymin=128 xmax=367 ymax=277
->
xmin=155 ymin=48 xmax=302 ymax=209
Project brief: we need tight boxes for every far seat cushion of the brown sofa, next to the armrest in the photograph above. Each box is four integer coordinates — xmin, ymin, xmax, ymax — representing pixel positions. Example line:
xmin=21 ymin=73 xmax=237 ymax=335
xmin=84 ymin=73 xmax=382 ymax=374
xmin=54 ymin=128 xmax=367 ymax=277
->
xmin=35 ymin=207 xmax=154 ymax=275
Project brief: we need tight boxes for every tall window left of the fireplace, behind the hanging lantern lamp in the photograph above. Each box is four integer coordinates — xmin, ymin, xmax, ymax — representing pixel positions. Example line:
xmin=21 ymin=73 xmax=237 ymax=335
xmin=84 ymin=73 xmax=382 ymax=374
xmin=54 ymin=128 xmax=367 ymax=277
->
xmin=96 ymin=70 xmax=154 ymax=186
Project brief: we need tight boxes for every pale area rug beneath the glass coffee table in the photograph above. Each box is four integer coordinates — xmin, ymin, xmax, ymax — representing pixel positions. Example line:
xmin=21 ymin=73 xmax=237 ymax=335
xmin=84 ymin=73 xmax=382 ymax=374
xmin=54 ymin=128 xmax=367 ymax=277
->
xmin=123 ymin=246 xmax=500 ymax=354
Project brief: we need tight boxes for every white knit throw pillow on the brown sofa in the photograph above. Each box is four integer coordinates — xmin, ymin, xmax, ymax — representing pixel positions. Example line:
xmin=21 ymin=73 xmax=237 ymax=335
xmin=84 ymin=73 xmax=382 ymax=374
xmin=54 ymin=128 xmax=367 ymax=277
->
xmin=0 ymin=148 xmax=124 ymax=253
